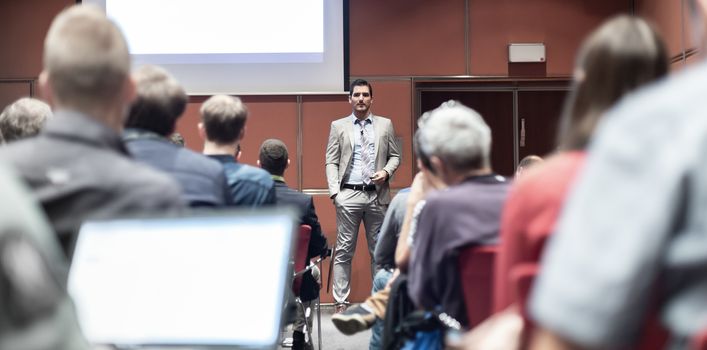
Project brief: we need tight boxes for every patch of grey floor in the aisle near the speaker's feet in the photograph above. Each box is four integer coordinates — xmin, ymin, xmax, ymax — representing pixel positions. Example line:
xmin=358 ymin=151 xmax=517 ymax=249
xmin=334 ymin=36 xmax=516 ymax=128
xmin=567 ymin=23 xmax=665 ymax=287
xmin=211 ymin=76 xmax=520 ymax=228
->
xmin=280 ymin=304 xmax=371 ymax=350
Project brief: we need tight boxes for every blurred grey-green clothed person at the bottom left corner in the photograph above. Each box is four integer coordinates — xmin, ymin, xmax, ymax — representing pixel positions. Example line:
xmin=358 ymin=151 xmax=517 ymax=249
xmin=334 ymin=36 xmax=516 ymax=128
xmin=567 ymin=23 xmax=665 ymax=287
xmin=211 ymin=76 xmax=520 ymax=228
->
xmin=0 ymin=166 xmax=90 ymax=350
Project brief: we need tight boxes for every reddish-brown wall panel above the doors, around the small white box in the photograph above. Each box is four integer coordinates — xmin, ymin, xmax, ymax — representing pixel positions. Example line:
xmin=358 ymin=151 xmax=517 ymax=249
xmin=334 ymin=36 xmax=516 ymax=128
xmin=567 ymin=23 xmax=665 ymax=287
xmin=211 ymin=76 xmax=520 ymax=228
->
xmin=469 ymin=0 xmax=630 ymax=76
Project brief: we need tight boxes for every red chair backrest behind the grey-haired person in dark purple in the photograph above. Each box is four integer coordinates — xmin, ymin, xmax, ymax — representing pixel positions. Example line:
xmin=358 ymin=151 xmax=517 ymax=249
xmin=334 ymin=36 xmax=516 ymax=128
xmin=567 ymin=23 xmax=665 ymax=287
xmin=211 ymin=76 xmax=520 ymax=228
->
xmin=458 ymin=246 xmax=498 ymax=328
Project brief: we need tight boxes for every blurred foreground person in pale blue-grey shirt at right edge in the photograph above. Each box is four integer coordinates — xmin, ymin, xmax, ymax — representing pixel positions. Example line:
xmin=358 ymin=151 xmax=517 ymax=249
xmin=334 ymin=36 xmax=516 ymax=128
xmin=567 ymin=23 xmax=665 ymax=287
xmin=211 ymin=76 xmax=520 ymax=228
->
xmin=529 ymin=9 xmax=707 ymax=350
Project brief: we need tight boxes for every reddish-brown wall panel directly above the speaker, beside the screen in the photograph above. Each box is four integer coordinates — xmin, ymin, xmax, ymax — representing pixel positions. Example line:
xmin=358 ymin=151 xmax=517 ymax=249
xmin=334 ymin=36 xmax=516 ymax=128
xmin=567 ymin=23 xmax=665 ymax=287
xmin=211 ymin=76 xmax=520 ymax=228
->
xmin=349 ymin=0 xmax=466 ymax=76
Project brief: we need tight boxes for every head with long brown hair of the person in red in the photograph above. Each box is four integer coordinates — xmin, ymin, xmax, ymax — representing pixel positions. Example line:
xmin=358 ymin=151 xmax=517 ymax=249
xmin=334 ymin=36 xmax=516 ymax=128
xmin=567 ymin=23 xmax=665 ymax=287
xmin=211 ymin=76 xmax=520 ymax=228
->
xmin=558 ymin=15 xmax=668 ymax=150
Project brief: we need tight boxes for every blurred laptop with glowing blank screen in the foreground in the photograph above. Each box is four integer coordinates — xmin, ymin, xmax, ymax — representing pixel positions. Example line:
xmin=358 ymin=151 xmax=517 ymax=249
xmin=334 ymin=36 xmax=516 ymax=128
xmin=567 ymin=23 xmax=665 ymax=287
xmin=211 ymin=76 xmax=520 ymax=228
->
xmin=68 ymin=209 xmax=296 ymax=349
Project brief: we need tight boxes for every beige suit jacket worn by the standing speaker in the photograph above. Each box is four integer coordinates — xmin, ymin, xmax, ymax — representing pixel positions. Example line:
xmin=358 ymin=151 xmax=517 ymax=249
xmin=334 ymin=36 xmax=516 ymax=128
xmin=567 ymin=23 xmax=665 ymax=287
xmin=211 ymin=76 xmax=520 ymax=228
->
xmin=326 ymin=115 xmax=400 ymax=205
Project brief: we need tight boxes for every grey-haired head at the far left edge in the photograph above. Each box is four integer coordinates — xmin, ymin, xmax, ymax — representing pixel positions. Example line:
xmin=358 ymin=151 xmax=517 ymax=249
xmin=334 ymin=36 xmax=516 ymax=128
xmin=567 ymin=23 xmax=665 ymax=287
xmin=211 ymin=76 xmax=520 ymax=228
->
xmin=0 ymin=97 xmax=52 ymax=143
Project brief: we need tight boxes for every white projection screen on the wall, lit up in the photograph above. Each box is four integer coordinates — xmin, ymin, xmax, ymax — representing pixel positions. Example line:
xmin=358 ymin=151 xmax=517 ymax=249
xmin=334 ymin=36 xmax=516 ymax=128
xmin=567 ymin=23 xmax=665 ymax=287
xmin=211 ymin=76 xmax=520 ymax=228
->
xmin=83 ymin=0 xmax=346 ymax=95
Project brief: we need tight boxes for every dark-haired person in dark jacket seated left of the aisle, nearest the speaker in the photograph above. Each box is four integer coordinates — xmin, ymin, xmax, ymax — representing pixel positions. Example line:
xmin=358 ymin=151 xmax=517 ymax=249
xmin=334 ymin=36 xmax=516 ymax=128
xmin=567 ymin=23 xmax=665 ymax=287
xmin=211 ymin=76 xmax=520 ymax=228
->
xmin=258 ymin=139 xmax=329 ymax=350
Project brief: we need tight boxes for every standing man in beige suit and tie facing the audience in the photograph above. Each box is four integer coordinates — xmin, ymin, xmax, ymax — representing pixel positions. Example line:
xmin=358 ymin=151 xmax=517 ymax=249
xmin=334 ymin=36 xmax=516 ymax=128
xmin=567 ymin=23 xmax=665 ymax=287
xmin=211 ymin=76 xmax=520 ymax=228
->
xmin=326 ymin=79 xmax=400 ymax=312
